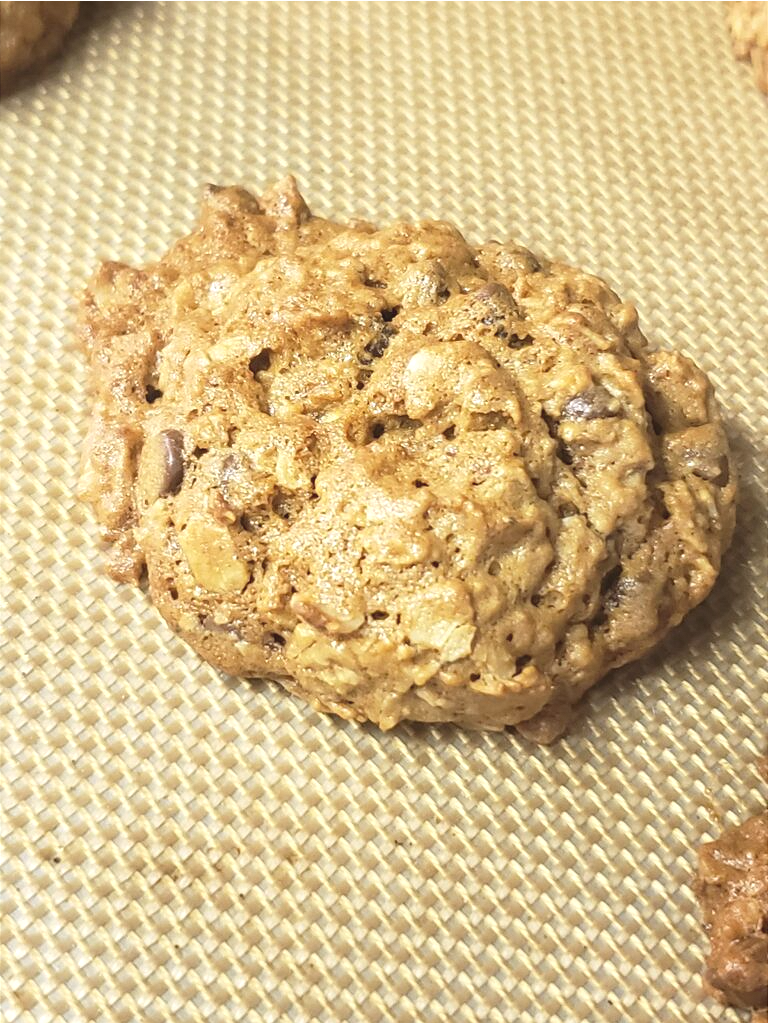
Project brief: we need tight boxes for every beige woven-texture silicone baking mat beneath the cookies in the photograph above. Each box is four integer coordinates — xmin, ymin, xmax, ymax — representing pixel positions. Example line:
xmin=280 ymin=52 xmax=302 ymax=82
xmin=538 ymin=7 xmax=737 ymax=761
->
xmin=0 ymin=2 xmax=768 ymax=1021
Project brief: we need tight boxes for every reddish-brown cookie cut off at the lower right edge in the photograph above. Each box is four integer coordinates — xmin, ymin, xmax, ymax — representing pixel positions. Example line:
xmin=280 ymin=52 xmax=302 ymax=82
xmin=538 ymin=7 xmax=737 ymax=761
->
xmin=696 ymin=765 xmax=768 ymax=1024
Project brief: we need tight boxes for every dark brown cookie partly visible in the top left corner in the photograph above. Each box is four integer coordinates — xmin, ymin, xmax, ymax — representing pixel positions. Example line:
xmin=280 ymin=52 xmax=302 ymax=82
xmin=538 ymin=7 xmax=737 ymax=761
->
xmin=0 ymin=0 xmax=80 ymax=92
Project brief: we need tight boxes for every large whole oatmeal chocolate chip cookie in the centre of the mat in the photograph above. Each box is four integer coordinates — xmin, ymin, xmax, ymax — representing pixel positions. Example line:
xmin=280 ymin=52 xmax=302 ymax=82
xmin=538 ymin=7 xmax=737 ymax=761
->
xmin=82 ymin=178 xmax=735 ymax=740
